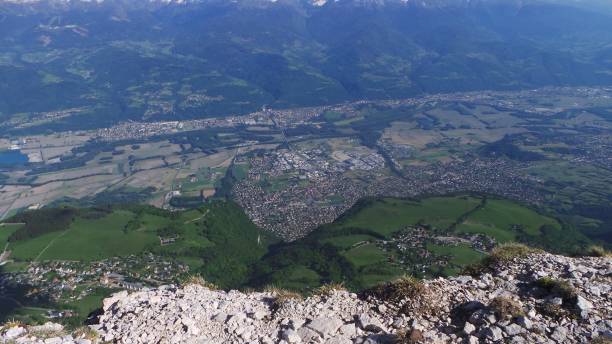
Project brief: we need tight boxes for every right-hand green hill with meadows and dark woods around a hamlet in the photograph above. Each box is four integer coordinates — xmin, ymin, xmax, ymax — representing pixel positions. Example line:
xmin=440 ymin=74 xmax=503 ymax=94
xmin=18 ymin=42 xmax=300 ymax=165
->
xmin=256 ymin=195 xmax=584 ymax=289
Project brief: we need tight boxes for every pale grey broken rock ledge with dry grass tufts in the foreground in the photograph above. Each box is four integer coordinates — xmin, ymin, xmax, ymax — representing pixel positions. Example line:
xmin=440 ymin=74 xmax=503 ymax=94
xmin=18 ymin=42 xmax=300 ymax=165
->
xmin=1 ymin=254 xmax=612 ymax=344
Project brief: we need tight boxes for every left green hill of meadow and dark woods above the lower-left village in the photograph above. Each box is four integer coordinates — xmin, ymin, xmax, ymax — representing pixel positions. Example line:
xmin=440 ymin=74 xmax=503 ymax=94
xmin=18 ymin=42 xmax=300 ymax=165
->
xmin=0 ymin=201 xmax=270 ymax=286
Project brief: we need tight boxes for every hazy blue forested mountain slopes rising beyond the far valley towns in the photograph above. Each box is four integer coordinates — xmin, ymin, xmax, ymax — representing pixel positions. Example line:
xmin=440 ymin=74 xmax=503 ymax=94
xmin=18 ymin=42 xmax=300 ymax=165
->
xmin=0 ymin=0 xmax=612 ymax=131
